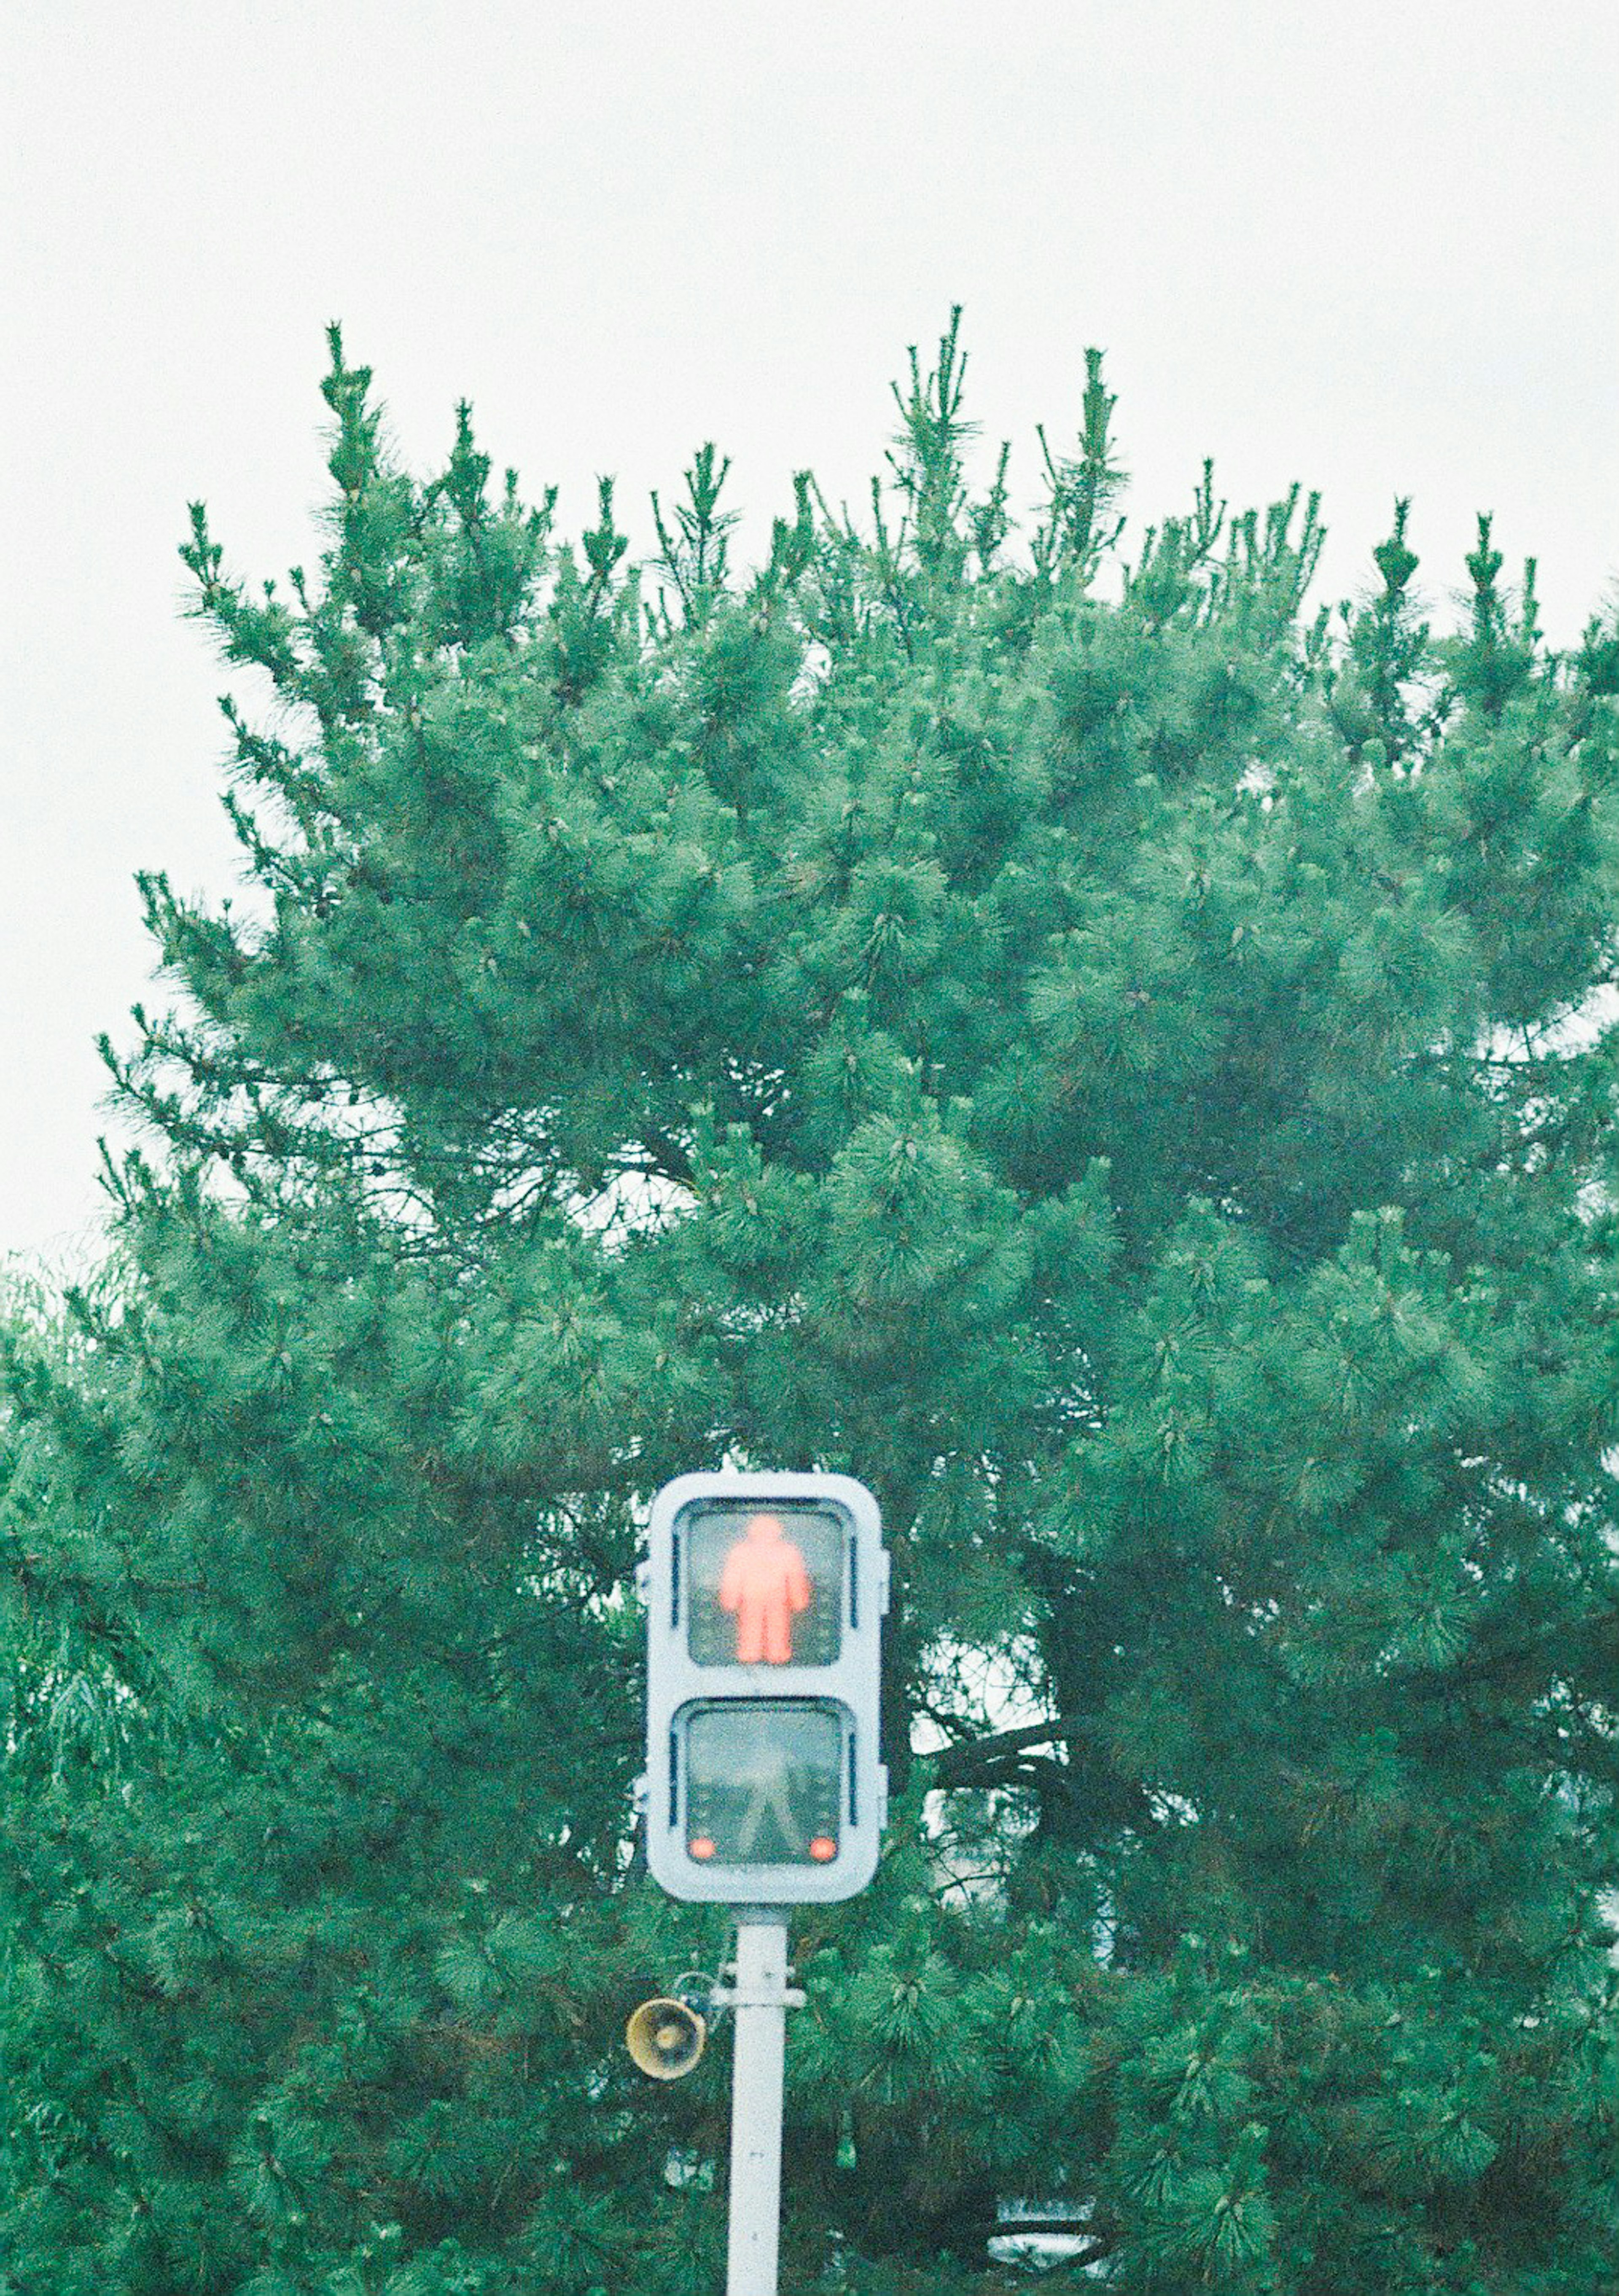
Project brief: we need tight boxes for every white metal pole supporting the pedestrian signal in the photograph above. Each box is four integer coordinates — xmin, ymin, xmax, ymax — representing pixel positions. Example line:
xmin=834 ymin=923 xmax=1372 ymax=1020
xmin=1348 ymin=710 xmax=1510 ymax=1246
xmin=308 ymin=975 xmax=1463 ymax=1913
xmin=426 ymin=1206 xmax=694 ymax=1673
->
xmin=726 ymin=1906 xmax=804 ymax=2296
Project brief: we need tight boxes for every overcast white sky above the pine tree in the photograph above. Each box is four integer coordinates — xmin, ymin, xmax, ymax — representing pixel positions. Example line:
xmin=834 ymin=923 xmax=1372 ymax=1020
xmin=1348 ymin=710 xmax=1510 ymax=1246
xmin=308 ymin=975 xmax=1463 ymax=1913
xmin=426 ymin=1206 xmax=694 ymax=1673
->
xmin=0 ymin=0 xmax=1619 ymax=1258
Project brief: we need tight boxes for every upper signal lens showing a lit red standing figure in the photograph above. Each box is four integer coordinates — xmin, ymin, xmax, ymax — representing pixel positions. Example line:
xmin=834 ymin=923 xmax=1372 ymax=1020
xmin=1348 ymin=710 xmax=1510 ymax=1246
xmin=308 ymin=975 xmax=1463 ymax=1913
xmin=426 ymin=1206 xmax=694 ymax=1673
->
xmin=675 ymin=1499 xmax=852 ymax=1667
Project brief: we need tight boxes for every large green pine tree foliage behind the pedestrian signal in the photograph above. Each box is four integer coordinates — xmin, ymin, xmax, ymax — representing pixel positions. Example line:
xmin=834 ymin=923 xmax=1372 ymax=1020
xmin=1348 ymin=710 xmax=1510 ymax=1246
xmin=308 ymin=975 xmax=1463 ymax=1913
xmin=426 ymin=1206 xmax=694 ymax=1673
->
xmin=0 ymin=321 xmax=1619 ymax=2296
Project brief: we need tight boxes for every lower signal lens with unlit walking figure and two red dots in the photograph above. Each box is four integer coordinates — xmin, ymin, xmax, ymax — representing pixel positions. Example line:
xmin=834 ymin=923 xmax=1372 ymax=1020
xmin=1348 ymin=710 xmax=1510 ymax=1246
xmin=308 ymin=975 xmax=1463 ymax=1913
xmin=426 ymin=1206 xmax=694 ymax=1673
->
xmin=682 ymin=1699 xmax=852 ymax=1867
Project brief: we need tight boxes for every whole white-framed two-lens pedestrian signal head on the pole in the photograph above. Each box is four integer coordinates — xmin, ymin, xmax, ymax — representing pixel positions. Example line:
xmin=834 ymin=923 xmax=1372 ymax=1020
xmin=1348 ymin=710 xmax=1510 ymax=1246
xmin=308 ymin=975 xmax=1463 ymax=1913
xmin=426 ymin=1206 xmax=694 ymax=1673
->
xmin=643 ymin=1474 xmax=889 ymax=1906
